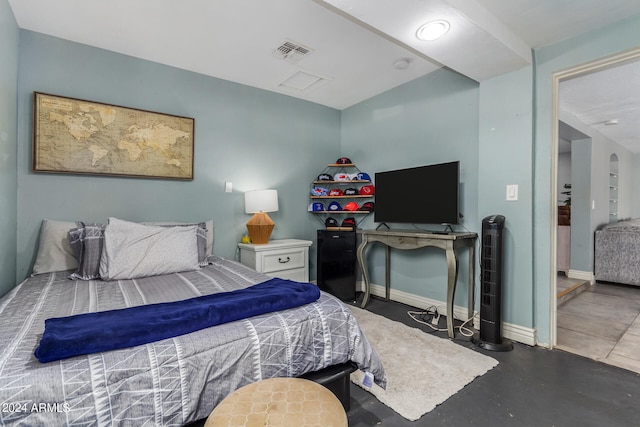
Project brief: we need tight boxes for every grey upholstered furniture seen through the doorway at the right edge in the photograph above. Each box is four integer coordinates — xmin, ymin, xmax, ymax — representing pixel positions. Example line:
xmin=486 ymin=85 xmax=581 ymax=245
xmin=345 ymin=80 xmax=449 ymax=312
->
xmin=595 ymin=219 xmax=640 ymax=286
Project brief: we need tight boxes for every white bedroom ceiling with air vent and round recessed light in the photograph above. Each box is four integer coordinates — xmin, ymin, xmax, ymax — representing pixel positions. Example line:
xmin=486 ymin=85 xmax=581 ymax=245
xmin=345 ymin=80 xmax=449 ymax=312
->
xmin=8 ymin=0 xmax=640 ymax=149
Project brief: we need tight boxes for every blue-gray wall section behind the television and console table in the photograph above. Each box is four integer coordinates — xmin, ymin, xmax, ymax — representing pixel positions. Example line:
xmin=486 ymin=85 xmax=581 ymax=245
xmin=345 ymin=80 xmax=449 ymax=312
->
xmin=342 ymin=69 xmax=478 ymax=306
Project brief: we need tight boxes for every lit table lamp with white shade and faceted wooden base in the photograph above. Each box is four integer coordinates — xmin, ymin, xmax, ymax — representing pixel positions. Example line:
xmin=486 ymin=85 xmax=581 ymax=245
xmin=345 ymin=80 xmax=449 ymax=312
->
xmin=244 ymin=190 xmax=278 ymax=245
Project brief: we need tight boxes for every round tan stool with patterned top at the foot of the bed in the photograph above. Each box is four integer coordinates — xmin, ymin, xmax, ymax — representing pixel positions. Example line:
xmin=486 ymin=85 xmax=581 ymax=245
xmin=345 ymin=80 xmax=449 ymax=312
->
xmin=205 ymin=378 xmax=347 ymax=427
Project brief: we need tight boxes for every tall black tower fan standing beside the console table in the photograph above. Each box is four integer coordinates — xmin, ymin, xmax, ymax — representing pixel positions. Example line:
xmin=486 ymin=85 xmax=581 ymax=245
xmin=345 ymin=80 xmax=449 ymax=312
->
xmin=471 ymin=215 xmax=513 ymax=351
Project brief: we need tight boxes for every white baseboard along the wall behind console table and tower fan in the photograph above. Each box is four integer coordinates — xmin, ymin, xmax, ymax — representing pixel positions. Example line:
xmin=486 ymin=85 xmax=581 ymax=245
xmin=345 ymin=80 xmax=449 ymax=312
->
xmin=357 ymin=282 xmax=536 ymax=346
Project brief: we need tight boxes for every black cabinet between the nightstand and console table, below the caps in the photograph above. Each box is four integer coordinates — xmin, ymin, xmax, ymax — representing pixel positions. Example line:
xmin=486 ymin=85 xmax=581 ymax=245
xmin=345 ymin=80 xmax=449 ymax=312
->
xmin=317 ymin=230 xmax=356 ymax=301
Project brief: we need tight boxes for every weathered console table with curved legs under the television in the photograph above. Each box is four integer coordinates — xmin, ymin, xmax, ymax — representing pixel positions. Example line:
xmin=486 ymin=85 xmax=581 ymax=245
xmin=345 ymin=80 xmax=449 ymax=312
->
xmin=357 ymin=230 xmax=478 ymax=338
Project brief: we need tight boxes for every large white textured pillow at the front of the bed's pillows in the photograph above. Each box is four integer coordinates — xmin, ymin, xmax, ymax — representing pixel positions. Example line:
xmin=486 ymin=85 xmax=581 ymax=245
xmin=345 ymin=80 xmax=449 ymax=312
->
xmin=100 ymin=218 xmax=199 ymax=280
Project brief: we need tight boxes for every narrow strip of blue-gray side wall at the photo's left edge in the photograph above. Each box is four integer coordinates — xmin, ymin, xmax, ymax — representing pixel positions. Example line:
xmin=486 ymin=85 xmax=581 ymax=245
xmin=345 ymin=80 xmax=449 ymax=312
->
xmin=0 ymin=0 xmax=19 ymax=295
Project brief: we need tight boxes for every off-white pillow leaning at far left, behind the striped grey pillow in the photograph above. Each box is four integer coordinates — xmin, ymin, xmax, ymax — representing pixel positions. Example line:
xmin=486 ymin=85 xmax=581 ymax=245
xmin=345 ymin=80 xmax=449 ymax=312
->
xmin=32 ymin=219 xmax=78 ymax=274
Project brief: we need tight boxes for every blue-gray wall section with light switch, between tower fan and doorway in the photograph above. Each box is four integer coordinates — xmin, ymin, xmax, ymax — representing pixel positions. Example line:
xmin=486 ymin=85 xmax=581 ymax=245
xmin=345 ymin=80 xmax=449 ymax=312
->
xmin=478 ymin=67 xmax=535 ymax=329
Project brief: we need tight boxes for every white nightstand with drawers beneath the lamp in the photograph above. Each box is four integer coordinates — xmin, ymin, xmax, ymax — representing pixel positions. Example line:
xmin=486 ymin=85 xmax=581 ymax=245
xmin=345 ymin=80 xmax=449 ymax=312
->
xmin=238 ymin=239 xmax=313 ymax=282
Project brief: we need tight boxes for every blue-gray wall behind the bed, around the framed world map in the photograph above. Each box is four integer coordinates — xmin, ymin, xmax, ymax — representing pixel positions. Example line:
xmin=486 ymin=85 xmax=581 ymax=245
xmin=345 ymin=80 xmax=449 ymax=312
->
xmin=14 ymin=30 xmax=340 ymax=280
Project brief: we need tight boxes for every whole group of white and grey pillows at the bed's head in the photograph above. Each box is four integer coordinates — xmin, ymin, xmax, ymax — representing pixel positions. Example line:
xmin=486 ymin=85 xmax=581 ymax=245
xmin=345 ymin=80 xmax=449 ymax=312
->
xmin=33 ymin=218 xmax=213 ymax=280
